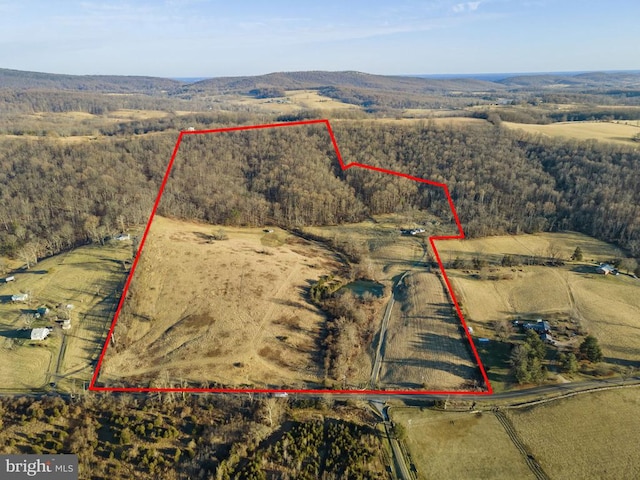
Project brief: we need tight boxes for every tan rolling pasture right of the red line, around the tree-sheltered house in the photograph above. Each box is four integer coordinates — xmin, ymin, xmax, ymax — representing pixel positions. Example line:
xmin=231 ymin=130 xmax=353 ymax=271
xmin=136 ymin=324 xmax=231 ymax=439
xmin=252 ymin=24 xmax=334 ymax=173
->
xmin=438 ymin=233 xmax=640 ymax=390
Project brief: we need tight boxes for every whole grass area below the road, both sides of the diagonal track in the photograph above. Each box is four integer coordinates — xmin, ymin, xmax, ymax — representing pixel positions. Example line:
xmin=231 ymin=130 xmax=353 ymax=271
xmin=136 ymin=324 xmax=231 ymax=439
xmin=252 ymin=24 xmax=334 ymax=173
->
xmin=390 ymin=387 xmax=640 ymax=480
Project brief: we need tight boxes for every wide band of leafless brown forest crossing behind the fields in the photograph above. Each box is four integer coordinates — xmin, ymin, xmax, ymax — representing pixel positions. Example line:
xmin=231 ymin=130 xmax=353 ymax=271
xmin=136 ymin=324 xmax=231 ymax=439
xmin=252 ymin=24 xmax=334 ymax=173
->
xmin=0 ymin=118 xmax=640 ymax=270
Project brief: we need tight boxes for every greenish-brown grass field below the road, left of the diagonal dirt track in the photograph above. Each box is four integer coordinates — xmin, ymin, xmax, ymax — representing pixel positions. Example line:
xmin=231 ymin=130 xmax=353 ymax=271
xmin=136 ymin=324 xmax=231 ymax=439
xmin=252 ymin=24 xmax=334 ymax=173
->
xmin=390 ymin=408 xmax=532 ymax=480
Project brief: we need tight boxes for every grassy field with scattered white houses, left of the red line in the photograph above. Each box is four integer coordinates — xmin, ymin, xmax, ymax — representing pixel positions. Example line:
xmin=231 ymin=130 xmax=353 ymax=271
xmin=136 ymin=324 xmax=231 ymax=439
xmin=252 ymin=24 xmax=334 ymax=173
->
xmin=0 ymin=242 xmax=131 ymax=390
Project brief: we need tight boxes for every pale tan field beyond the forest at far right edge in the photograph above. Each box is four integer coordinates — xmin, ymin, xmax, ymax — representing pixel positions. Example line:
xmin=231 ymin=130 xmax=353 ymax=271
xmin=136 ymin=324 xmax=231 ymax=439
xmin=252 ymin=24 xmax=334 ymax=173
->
xmin=502 ymin=120 xmax=640 ymax=147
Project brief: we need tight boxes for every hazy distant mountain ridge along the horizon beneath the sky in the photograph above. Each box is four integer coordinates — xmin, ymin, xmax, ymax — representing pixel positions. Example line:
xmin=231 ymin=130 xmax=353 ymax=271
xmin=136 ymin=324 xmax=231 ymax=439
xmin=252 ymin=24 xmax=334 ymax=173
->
xmin=0 ymin=69 xmax=640 ymax=96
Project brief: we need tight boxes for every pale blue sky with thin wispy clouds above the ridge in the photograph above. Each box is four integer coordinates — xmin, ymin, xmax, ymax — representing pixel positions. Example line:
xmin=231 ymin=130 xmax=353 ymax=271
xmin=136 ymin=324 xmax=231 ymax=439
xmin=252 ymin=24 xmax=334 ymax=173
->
xmin=0 ymin=0 xmax=640 ymax=78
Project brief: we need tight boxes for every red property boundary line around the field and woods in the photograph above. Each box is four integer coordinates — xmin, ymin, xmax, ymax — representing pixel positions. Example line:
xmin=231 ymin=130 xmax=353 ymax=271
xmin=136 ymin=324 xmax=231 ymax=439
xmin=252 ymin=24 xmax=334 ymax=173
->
xmin=89 ymin=119 xmax=493 ymax=395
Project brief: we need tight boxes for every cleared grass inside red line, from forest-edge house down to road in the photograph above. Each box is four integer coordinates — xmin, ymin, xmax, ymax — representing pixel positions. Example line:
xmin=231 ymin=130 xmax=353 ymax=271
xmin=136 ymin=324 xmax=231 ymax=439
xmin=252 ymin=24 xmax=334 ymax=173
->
xmin=308 ymin=212 xmax=477 ymax=390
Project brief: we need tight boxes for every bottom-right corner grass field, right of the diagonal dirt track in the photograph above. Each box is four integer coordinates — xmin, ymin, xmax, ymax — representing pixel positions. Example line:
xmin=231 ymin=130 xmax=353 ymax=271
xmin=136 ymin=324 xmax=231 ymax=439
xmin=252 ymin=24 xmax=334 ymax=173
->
xmin=507 ymin=387 xmax=640 ymax=480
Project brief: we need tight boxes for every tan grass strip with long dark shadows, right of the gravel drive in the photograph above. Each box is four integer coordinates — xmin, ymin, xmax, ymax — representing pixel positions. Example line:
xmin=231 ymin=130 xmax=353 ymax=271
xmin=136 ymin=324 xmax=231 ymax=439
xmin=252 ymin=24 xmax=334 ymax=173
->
xmin=380 ymin=272 xmax=477 ymax=391
